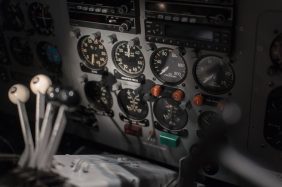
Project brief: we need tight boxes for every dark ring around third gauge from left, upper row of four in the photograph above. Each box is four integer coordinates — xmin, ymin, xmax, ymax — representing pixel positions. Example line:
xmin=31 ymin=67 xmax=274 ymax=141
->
xmin=150 ymin=47 xmax=189 ymax=86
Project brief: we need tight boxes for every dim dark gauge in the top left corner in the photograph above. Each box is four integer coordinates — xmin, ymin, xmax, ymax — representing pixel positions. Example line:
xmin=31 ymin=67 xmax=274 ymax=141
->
xmin=3 ymin=0 xmax=25 ymax=31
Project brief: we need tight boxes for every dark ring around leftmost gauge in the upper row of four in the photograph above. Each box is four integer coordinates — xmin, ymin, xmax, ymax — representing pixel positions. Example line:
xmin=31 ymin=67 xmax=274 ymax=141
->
xmin=77 ymin=35 xmax=109 ymax=70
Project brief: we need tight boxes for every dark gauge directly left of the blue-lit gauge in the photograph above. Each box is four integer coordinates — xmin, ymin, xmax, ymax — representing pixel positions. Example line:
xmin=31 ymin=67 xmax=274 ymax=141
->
xmin=10 ymin=37 xmax=33 ymax=66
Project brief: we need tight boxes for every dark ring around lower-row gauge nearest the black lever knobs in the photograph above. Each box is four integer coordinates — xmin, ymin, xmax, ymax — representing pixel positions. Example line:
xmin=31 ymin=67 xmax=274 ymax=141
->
xmin=83 ymin=81 xmax=114 ymax=112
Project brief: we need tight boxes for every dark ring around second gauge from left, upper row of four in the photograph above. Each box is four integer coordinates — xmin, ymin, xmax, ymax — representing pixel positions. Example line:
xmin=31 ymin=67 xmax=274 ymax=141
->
xmin=112 ymin=41 xmax=146 ymax=78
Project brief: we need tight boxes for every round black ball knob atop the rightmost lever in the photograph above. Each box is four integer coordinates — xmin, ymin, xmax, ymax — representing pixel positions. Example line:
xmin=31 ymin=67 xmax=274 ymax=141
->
xmin=59 ymin=88 xmax=80 ymax=107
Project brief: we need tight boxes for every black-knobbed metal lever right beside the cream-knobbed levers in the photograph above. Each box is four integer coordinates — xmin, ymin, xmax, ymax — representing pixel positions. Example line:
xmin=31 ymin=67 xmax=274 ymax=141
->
xmin=29 ymin=86 xmax=61 ymax=168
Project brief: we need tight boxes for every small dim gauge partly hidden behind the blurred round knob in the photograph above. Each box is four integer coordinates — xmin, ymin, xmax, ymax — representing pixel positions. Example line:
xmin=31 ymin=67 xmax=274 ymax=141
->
xmin=198 ymin=111 xmax=221 ymax=130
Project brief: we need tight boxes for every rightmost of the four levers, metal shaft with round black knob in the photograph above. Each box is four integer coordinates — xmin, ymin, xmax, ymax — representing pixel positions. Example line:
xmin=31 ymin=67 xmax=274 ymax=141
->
xmin=38 ymin=89 xmax=80 ymax=170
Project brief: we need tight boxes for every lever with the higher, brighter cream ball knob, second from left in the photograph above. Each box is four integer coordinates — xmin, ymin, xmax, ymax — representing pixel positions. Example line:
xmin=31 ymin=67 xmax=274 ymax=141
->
xmin=30 ymin=75 xmax=52 ymax=146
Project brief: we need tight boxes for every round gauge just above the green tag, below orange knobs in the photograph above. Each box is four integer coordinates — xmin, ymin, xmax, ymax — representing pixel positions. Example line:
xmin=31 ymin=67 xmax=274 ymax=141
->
xmin=154 ymin=98 xmax=188 ymax=131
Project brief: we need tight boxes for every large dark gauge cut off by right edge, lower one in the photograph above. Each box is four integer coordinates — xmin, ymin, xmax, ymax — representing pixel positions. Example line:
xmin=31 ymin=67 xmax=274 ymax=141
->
xmin=264 ymin=87 xmax=282 ymax=150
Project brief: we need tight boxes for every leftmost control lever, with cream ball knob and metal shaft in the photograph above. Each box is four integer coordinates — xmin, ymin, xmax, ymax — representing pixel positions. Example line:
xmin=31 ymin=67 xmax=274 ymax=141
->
xmin=8 ymin=84 xmax=34 ymax=167
